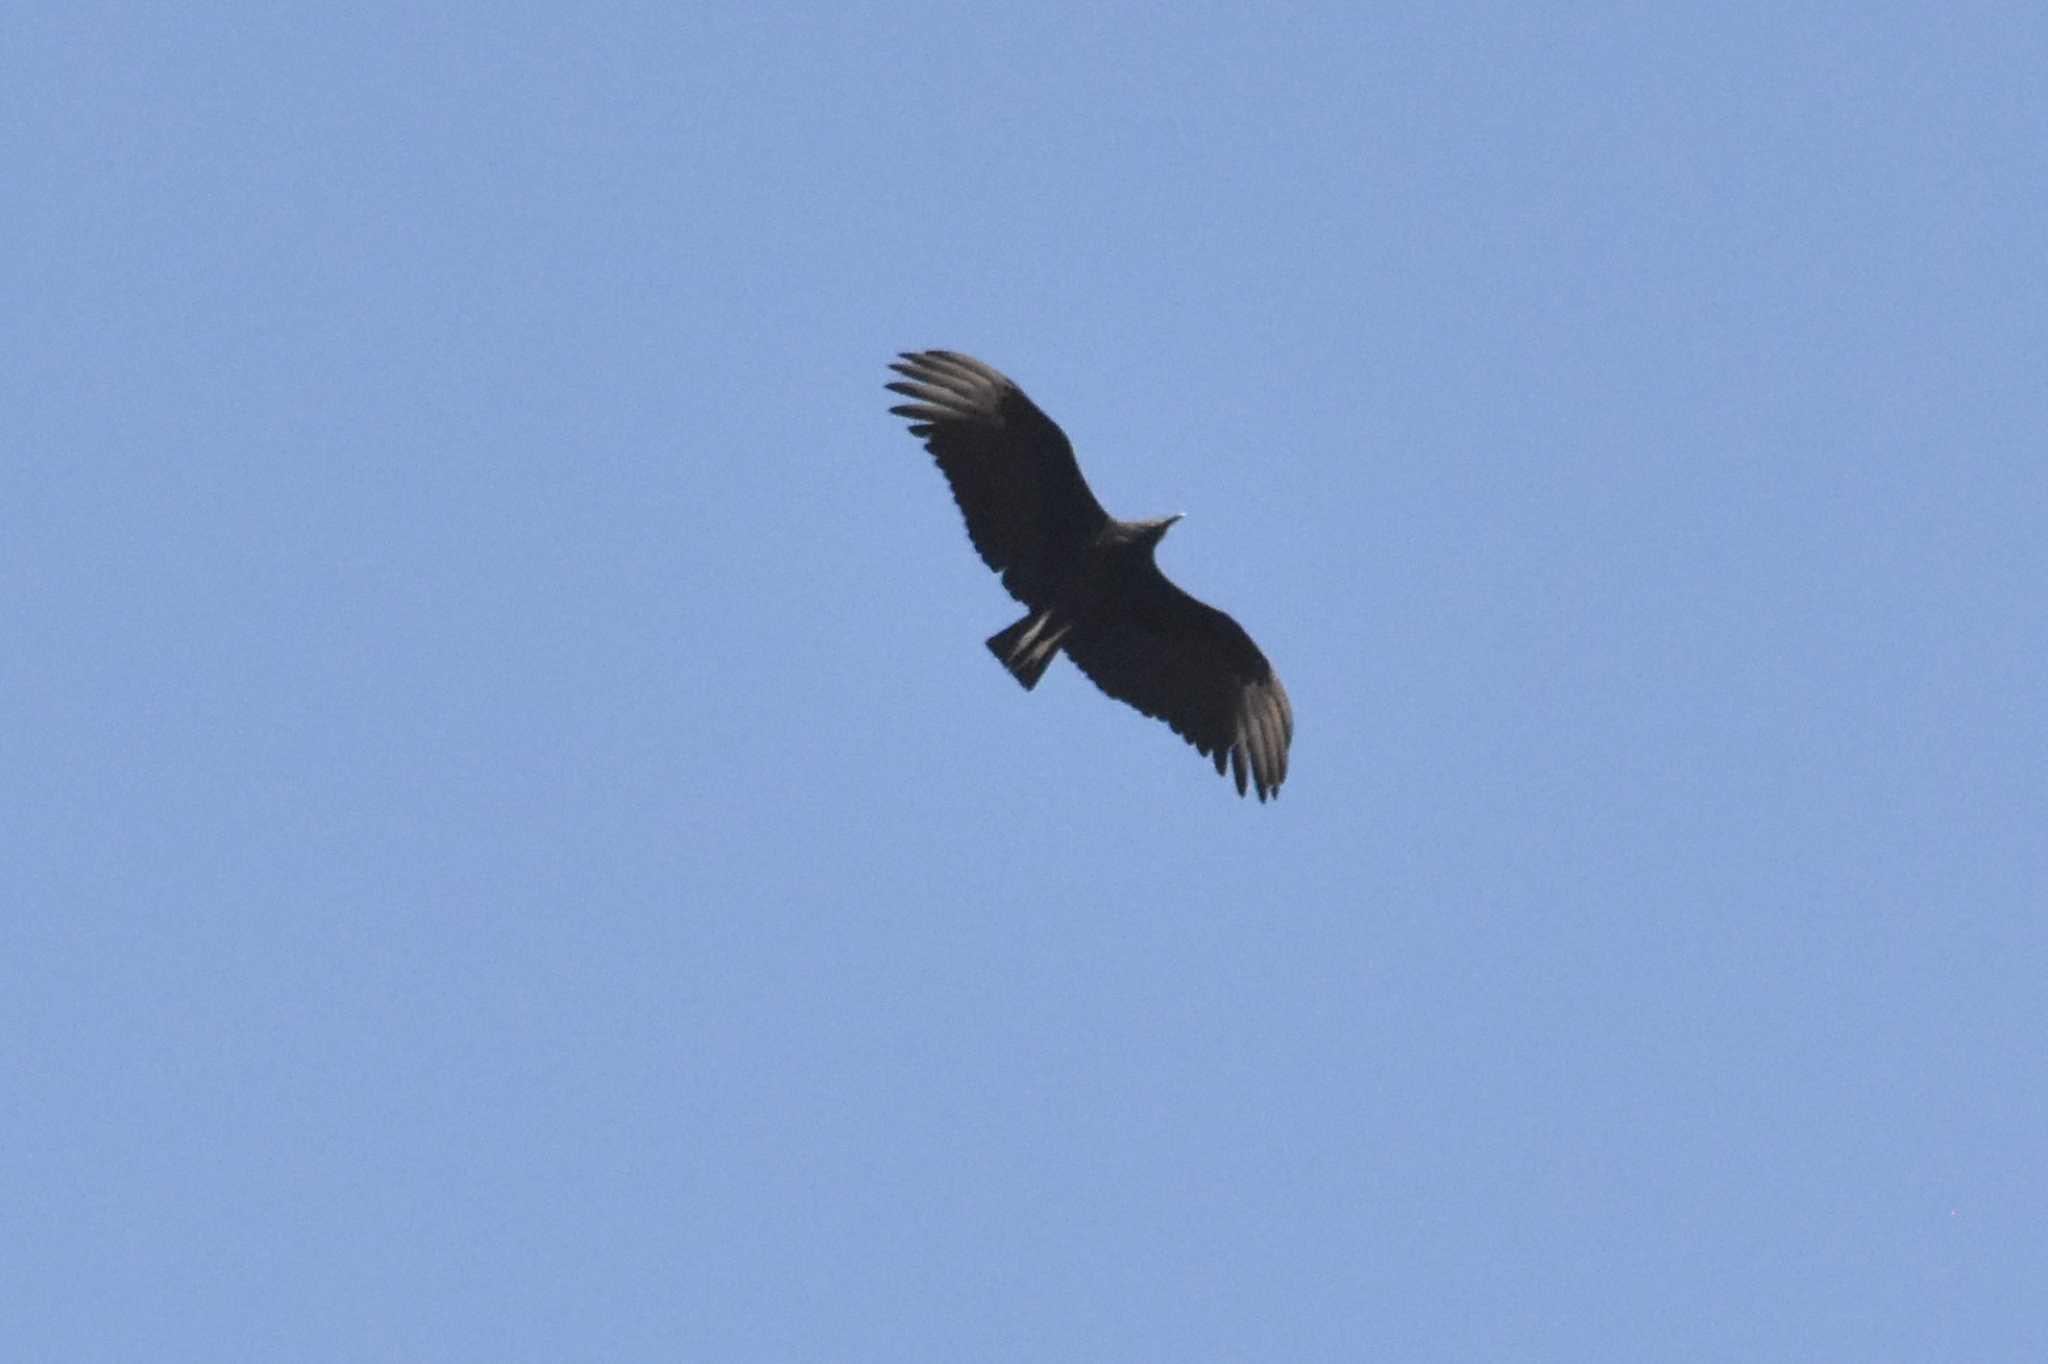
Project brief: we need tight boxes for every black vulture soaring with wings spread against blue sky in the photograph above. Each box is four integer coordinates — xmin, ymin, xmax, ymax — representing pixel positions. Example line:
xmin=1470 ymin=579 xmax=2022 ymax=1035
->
xmin=889 ymin=350 xmax=1294 ymax=801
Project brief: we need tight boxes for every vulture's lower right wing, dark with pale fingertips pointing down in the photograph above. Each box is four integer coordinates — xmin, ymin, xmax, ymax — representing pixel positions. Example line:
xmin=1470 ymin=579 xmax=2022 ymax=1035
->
xmin=1065 ymin=569 xmax=1294 ymax=801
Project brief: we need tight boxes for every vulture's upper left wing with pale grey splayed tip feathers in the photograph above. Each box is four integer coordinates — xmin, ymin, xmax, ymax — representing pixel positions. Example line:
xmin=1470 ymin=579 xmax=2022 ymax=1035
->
xmin=889 ymin=350 xmax=1108 ymax=606
